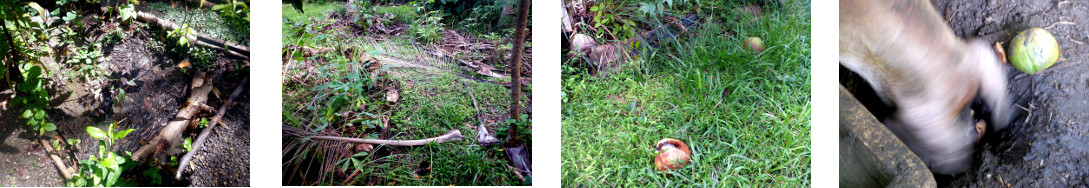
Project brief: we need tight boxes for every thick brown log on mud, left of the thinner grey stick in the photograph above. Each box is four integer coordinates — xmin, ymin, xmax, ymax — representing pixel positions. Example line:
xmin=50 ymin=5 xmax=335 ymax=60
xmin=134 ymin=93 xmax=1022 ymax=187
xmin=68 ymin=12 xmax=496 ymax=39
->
xmin=131 ymin=72 xmax=215 ymax=162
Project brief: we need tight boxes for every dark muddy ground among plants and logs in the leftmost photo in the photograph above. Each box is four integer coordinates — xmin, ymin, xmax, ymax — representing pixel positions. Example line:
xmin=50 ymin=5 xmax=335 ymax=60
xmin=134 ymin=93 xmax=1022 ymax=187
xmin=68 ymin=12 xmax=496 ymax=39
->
xmin=0 ymin=2 xmax=250 ymax=187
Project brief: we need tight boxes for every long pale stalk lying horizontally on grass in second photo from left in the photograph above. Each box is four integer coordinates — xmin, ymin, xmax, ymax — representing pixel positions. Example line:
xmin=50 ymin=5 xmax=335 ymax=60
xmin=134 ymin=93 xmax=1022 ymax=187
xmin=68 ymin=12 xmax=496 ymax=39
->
xmin=281 ymin=125 xmax=465 ymax=147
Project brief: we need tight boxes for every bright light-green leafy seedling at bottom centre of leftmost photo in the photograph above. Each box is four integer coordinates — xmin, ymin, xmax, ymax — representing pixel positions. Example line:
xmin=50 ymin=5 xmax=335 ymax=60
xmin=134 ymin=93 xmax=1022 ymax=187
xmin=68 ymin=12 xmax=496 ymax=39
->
xmin=66 ymin=122 xmax=136 ymax=187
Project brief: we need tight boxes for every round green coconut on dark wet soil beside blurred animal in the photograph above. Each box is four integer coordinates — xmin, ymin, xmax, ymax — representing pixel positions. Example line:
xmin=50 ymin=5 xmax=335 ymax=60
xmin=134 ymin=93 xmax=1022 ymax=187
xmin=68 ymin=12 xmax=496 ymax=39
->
xmin=1006 ymin=28 xmax=1060 ymax=74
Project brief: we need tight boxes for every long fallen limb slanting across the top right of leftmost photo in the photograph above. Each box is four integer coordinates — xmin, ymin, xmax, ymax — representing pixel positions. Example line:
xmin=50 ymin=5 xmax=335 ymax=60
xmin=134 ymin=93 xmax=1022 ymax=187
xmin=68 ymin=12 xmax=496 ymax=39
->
xmin=100 ymin=7 xmax=249 ymax=59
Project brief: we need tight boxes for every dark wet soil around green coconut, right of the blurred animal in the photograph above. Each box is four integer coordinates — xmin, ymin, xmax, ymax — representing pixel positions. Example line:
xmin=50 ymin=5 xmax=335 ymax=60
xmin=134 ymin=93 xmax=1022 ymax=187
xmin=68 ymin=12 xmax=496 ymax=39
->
xmin=932 ymin=0 xmax=1089 ymax=187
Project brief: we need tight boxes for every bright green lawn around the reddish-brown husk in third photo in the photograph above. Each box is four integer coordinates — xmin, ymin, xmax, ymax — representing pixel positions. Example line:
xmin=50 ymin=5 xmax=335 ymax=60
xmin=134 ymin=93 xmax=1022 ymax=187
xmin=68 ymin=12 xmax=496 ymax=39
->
xmin=561 ymin=2 xmax=811 ymax=187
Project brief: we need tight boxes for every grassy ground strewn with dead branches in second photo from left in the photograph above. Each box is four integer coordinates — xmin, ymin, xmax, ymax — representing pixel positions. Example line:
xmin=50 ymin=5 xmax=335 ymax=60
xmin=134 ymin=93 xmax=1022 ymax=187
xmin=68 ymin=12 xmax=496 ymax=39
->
xmin=283 ymin=3 xmax=533 ymax=186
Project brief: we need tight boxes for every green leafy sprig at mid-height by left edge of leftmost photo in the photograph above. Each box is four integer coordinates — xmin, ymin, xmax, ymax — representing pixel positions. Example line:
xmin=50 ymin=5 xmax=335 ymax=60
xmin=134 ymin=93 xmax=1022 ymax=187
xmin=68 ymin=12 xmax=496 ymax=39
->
xmin=15 ymin=64 xmax=57 ymax=135
